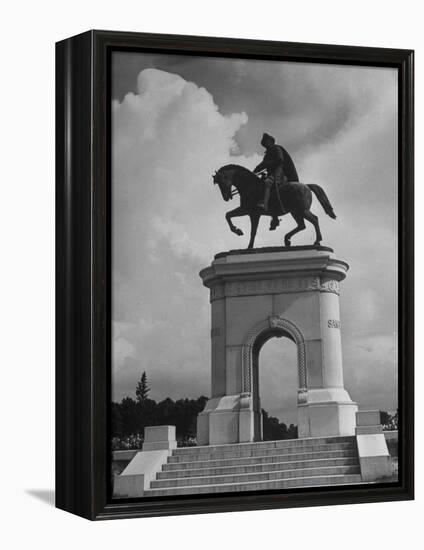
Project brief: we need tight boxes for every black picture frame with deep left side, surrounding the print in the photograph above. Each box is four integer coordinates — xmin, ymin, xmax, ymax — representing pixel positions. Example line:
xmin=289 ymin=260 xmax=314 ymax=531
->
xmin=56 ymin=31 xmax=414 ymax=520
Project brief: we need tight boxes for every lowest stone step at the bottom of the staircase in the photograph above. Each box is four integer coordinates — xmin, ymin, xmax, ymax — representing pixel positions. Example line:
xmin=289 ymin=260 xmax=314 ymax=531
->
xmin=144 ymin=474 xmax=362 ymax=497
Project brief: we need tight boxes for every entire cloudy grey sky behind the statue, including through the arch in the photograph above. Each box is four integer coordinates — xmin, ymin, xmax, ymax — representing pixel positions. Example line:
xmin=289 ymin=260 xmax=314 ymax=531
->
xmin=112 ymin=53 xmax=397 ymax=421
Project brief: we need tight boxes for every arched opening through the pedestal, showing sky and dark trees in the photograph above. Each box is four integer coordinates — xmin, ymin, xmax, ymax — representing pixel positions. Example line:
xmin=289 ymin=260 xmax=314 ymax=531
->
xmin=252 ymin=330 xmax=299 ymax=441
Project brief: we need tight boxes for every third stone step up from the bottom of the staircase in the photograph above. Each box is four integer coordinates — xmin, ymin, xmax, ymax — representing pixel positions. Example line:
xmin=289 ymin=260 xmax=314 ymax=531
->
xmin=157 ymin=457 xmax=358 ymax=480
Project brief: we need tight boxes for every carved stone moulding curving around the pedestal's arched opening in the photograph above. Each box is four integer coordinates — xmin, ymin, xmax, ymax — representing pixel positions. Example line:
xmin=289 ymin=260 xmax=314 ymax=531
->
xmin=242 ymin=315 xmax=307 ymax=402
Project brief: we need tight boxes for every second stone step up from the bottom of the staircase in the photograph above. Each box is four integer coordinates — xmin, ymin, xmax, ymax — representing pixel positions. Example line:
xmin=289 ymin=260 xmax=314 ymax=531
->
xmin=150 ymin=465 xmax=360 ymax=489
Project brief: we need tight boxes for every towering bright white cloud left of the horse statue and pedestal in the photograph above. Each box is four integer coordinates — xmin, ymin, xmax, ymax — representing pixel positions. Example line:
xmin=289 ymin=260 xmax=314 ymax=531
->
xmin=112 ymin=69 xmax=258 ymax=398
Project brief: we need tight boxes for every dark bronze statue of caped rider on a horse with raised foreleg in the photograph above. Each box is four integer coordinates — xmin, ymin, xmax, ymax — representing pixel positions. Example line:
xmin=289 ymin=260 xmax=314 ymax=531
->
xmin=212 ymin=133 xmax=336 ymax=248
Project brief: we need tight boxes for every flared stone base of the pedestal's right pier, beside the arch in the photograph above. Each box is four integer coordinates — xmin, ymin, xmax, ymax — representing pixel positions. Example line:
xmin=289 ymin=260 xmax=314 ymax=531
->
xmin=298 ymin=388 xmax=358 ymax=437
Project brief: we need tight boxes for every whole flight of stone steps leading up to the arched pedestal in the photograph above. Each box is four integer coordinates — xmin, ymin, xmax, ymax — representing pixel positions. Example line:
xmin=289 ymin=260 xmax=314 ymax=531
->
xmin=144 ymin=437 xmax=362 ymax=496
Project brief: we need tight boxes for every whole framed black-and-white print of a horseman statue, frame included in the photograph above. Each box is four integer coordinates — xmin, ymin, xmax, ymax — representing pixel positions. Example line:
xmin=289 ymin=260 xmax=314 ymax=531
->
xmin=56 ymin=31 xmax=413 ymax=519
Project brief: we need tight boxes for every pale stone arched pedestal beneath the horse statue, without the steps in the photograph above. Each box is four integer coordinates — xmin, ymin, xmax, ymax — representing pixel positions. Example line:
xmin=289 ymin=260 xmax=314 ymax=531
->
xmin=197 ymin=246 xmax=358 ymax=445
